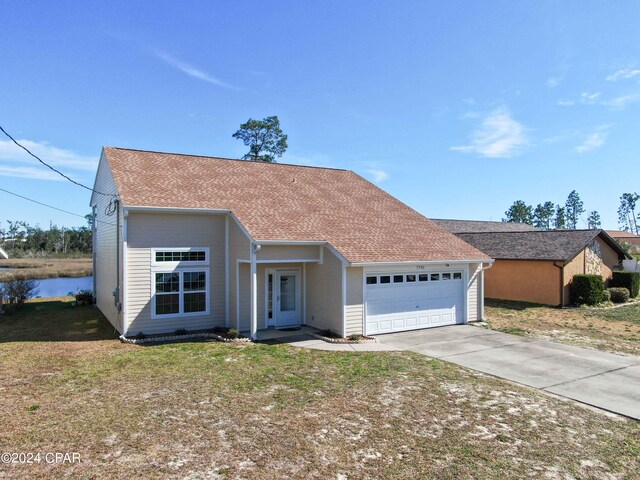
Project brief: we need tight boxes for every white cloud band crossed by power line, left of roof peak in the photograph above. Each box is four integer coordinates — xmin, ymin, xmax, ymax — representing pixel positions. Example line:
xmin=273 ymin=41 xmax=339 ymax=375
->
xmin=0 ymin=139 xmax=98 ymax=171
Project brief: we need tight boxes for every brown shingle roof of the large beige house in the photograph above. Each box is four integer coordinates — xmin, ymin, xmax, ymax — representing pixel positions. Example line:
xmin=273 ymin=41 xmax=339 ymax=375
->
xmin=104 ymin=147 xmax=489 ymax=263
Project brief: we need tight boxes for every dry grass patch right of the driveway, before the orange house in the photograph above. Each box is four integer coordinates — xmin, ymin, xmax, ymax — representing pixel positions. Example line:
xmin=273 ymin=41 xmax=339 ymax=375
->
xmin=485 ymin=300 xmax=640 ymax=355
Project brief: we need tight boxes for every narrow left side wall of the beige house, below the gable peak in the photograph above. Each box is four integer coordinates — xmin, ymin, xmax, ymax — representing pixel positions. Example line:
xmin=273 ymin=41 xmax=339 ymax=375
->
xmin=91 ymin=156 xmax=122 ymax=333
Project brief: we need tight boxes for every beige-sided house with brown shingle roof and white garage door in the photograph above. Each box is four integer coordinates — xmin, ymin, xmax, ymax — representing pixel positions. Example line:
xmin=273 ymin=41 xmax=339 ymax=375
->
xmin=91 ymin=147 xmax=492 ymax=338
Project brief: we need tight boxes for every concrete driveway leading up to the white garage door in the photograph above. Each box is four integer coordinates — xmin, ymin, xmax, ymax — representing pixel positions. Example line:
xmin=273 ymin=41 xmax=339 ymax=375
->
xmin=376 ymin=325 xmax=640 ymax=420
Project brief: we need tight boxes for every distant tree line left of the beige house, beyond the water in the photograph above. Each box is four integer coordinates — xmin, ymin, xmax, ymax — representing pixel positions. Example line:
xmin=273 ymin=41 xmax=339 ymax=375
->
xmin=0 ymin=214 xmax=93 ymax=257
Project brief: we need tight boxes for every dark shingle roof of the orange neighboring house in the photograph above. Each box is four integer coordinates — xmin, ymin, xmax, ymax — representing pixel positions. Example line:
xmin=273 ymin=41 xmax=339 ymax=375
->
xmin=457 ymin=230 xmax=630 ymax=262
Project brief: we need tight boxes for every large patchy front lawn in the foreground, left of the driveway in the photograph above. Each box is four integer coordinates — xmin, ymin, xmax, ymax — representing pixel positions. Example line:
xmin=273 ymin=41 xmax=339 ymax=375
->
xmin=0 ymin=299 xmax=640 ymax=479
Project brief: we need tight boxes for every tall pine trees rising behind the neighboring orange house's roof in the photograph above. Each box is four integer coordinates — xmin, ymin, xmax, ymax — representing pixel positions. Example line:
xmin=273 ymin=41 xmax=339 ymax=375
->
xmin=502 ymin=190 xmax=640 ymax=235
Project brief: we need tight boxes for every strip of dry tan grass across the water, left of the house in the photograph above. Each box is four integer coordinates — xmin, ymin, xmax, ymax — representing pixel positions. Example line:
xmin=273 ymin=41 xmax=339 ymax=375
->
xmin=0 ymin=258 xmax=93 ymax=282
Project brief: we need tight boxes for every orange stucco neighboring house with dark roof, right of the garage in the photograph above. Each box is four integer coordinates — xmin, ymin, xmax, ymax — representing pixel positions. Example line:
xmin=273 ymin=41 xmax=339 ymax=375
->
xmin=432 ymin=220 xmax=630 ymax=305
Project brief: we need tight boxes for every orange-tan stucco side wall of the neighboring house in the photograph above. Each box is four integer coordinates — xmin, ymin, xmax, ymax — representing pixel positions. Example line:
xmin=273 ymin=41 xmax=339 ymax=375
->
xmin=485 ymin=260 xmax=560 ymax=305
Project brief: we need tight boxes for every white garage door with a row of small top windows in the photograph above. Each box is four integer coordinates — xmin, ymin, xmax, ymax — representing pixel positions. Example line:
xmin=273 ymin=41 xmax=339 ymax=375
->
xmin=365 ymin=272 xmax=464 ymax=335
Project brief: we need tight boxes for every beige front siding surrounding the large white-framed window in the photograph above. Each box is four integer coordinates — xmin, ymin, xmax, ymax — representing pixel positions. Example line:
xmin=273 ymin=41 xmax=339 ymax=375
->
xmin=126 ymin=212 xmax=225 ymax=335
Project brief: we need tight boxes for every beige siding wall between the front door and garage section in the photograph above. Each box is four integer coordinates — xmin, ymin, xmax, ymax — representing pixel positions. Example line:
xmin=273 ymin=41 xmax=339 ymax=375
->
xmin=307 ymin=247 xmax=344 ymax=335
